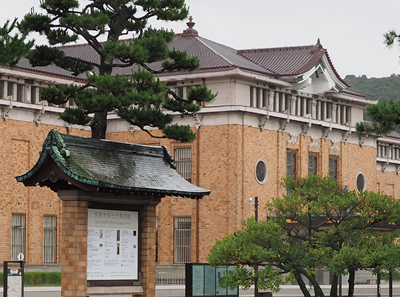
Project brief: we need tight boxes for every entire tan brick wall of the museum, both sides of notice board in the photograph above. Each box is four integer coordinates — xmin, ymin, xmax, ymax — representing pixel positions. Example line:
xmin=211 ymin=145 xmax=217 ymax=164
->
xmin=0 ymin=113 xmax=400 ymax=272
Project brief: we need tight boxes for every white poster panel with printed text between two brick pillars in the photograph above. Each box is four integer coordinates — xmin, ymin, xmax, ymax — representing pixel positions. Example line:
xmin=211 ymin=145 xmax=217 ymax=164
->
xmin=87 ymin=209 xmax=139 ymax=280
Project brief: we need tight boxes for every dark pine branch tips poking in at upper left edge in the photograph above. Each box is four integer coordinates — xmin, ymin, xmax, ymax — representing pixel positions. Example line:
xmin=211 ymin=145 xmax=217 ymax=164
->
xmin=0 ymin=19 xmax=34 ymax=66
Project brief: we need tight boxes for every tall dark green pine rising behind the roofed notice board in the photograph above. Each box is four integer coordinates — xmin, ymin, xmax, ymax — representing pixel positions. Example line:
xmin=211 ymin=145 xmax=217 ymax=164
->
xmin=19 ymin=0 xmax=215 ymax=141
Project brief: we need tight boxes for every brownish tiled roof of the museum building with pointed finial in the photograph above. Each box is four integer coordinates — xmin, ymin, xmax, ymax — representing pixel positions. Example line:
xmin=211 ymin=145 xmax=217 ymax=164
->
xmin=13 ymin=23 xmax=347 ymax=85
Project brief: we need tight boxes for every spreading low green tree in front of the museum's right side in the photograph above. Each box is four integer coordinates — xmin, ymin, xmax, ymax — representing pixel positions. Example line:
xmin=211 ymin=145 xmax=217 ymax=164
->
xmin=208 ymin=175 xmax=400 ymax=296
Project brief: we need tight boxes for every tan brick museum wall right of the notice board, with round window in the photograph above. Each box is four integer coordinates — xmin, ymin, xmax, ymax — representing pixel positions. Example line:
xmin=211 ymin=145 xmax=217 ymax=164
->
xmin=109 ymin=125 xmax=384 ymax=264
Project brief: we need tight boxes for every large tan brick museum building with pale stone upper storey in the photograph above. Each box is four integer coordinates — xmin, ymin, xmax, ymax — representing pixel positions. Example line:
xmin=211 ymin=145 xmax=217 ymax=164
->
xmin=0 ymin=21 xmax=400 ymax=286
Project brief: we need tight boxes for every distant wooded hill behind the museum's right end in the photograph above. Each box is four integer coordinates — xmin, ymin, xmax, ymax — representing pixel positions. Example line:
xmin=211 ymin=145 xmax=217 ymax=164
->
xmin=344 ymin=74 xmax=400 ymax=101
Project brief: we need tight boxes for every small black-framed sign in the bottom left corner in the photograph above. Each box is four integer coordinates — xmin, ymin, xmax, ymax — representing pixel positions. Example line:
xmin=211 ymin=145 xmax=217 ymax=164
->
xmin=3 ymin=261 xmax=24 ymax=297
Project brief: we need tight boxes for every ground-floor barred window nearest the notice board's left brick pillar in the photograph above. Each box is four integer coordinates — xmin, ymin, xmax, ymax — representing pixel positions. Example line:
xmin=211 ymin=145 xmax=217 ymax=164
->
xmin=43 ymin=215 xmax=57 ymax=263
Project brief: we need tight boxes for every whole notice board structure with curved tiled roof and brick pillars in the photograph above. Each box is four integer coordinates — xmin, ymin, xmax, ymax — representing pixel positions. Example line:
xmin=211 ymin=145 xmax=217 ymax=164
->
xmin=16 ymin=130 xmax=210 ymax=297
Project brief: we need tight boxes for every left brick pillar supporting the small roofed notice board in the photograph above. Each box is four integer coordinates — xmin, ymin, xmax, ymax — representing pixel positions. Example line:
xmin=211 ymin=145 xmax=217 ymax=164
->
xmin=61 ymin=201 xmax=88 ymax=297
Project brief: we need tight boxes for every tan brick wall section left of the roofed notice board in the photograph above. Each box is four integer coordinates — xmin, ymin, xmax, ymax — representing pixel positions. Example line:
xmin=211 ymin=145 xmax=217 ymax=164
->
xmin=0 ymin=119 xmax=90 ymax=264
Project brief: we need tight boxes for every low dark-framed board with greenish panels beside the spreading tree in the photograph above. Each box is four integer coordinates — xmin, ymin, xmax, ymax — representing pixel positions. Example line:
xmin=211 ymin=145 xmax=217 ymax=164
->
xmin=185 ymin=263 xmax=239 ymax=297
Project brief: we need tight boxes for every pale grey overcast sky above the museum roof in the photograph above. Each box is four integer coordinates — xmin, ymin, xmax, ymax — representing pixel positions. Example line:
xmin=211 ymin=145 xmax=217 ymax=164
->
xmin=0 ymin=0 xmax=400 ymax=78
